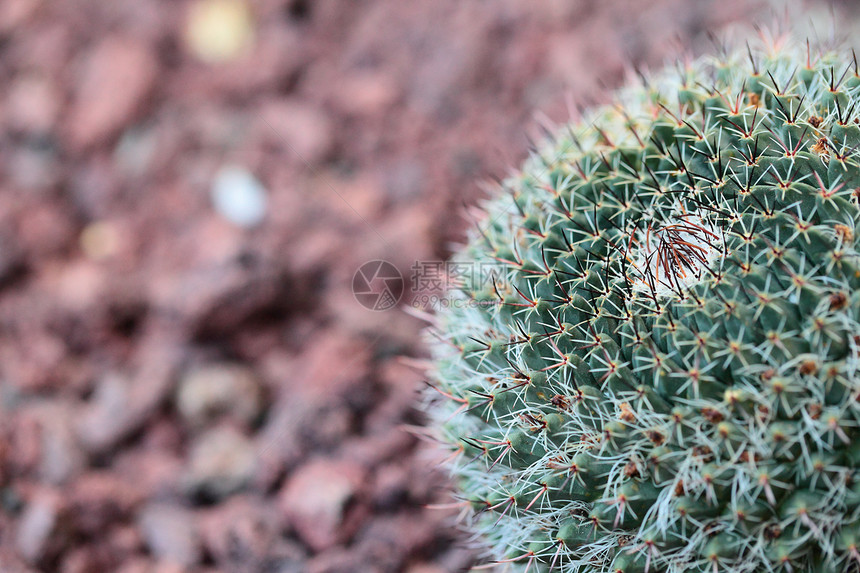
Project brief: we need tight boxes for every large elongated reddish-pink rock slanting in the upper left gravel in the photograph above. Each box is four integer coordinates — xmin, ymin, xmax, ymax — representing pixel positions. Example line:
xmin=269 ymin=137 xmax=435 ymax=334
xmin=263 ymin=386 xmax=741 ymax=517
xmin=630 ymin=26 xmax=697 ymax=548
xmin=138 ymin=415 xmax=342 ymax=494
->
xmin=68 ymin=36 xmax=158 ymax=148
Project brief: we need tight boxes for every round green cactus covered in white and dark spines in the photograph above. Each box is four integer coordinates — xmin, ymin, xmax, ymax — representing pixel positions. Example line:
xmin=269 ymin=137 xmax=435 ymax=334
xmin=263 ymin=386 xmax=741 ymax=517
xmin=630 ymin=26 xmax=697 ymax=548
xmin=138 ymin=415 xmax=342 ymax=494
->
xmin=430 ymin=33 xmax=860 ymax=573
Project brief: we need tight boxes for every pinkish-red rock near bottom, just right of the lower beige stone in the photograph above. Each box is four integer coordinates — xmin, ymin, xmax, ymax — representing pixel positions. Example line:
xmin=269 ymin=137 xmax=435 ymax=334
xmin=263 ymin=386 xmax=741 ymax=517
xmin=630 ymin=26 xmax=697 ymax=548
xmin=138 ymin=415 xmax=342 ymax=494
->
xmin=280 ymin=459 xmax=365 ymax=551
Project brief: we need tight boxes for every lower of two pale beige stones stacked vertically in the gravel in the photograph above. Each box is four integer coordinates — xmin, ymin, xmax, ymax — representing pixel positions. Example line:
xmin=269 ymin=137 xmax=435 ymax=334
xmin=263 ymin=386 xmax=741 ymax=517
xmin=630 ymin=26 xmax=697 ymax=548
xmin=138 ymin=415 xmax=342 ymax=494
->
xmin=186 ymin=426 xmax=257 ymax=499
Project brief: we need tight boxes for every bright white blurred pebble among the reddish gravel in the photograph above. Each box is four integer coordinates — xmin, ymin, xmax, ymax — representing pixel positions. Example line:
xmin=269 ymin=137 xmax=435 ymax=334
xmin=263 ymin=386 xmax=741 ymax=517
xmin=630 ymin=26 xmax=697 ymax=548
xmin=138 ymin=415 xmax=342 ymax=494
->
xmin=211 ymin=165 xmax=268 ymax=228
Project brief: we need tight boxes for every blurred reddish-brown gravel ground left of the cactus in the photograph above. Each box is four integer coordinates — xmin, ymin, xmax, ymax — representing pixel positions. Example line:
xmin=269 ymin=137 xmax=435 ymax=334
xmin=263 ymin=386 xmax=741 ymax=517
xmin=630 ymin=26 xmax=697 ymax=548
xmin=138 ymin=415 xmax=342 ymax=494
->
xmin=0 ymin=0 xmax=848 ymax=573
